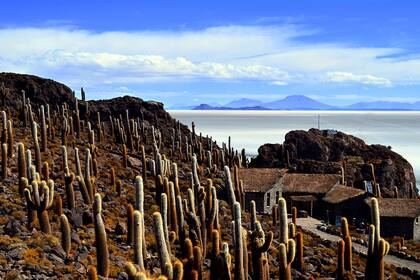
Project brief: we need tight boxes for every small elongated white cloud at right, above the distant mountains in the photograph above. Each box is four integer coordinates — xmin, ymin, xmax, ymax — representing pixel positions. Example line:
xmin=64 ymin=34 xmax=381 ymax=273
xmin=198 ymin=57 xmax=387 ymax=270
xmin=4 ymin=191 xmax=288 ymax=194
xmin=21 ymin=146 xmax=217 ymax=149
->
xmin=326 ymin=71 xmax=391 ymax=87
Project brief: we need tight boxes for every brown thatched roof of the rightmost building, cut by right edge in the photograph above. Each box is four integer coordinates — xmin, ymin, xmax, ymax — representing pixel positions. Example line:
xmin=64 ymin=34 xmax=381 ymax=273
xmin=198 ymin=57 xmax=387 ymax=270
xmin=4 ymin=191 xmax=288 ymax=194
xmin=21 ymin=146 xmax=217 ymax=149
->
xmin=365 ymin=198 xmax=420 ymax=218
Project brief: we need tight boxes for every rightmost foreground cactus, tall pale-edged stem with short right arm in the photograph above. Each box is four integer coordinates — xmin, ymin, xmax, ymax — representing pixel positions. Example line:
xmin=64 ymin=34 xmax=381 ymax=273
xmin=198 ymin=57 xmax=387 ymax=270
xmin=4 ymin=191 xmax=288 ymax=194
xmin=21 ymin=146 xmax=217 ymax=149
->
xmin=365 ymin=198 xmax=389 ymax=280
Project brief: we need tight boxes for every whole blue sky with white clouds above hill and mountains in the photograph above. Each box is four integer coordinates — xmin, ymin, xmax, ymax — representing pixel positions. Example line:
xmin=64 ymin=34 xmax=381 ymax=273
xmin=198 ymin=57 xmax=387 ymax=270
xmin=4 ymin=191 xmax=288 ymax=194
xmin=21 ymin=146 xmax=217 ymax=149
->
xmin=0 ymin=0 xmax=420 ymax=108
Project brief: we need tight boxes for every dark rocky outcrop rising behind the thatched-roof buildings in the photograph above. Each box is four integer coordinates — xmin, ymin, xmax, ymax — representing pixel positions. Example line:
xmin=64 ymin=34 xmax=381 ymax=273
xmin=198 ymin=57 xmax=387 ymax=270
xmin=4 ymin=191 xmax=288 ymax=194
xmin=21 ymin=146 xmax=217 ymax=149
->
xmin=250 ymin=129 xmax=416 ymax=197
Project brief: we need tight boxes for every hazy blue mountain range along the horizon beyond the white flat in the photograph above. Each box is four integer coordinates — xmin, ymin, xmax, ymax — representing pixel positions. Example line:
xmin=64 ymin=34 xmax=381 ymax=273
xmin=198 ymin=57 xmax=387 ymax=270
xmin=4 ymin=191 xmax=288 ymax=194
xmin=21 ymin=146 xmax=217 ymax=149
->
xmin=192 ymin=95 xmax=420 ymax=111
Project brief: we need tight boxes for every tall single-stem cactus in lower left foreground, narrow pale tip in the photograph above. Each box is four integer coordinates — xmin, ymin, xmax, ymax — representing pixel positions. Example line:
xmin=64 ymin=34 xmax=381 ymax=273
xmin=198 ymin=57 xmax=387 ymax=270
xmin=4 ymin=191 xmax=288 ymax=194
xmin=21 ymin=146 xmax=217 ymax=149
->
xmin=93 ymin=193 xmax=109 ymax=277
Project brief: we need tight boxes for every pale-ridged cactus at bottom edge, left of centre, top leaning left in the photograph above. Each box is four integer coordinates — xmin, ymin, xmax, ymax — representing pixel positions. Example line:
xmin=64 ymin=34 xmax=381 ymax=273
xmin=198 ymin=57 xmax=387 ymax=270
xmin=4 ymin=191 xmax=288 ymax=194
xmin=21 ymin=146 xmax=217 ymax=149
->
xmin=153 ymin=212 xmax=173 ymax=279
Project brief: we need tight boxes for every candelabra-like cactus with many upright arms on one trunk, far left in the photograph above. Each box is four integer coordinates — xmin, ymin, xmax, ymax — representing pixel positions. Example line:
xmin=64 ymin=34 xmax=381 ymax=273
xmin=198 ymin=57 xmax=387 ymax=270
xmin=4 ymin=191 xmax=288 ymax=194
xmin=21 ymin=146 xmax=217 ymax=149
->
xmin=24 ymin=180 xmax=54 ymax=234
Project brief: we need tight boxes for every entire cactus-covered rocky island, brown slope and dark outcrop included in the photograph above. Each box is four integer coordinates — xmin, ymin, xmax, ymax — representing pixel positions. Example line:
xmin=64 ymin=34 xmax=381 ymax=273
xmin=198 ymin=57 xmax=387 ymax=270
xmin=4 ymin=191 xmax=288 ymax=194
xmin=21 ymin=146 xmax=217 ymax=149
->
xmin=0 ymin=73 xmax=420 ymax=280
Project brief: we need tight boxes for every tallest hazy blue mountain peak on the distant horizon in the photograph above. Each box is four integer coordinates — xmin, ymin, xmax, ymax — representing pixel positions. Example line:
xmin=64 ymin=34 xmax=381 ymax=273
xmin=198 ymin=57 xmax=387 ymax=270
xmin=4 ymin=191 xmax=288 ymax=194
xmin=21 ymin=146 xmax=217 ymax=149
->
xmin=262 ymin=95 xmax=331 ymax=110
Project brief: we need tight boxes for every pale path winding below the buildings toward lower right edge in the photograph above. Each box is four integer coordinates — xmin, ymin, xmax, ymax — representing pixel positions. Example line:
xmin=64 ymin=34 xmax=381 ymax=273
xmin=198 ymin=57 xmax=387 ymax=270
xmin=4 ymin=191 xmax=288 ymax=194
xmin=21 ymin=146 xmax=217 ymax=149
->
xmin=297 ymin=218 xmax=420 ymax=272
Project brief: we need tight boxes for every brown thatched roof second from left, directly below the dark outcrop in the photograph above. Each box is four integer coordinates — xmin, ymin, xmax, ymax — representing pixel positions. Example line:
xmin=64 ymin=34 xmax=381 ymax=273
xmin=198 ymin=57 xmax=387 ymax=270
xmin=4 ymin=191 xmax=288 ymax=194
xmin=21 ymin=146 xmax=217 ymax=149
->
xmin=281 ymin=173 xmax=341 ymax=194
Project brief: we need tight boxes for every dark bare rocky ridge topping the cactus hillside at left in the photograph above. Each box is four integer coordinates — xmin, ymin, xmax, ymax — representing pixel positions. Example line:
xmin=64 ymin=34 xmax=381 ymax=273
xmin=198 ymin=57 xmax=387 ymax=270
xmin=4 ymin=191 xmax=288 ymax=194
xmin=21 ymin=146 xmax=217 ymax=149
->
xmin=0 ymin=73 xmax=187 ymax=135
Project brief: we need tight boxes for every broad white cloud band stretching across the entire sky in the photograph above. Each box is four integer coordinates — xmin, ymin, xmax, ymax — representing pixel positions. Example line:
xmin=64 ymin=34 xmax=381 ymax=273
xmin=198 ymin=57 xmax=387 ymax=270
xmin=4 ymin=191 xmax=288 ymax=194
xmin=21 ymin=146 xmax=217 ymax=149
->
xmin=0 ymin=25 xmax=420 ymax=87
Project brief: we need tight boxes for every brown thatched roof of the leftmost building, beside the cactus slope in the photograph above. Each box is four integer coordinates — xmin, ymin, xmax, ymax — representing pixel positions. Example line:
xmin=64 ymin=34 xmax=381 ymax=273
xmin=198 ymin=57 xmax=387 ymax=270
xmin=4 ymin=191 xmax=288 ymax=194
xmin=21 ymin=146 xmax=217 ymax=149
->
xmin=238 ymin=168 xmax=287 ymax=193
